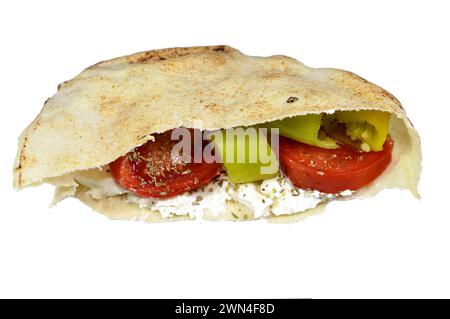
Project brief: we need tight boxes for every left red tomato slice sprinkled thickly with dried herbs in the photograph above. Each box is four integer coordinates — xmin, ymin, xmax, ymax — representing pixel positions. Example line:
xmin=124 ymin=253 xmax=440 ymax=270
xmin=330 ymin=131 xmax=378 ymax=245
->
xmin=109 ymin=130 xmax=222 ymax=198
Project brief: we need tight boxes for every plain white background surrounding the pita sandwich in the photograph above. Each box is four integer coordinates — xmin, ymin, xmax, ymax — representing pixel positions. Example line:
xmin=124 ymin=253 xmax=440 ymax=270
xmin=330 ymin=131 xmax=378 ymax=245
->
xmin=0 ymin=0 xmax=450 ymax=298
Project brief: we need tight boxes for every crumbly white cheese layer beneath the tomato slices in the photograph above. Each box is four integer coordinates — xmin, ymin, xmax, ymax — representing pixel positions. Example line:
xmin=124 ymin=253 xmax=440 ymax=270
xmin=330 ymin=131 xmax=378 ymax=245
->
xmin=74 ymin=171 xmax=352 ymax=219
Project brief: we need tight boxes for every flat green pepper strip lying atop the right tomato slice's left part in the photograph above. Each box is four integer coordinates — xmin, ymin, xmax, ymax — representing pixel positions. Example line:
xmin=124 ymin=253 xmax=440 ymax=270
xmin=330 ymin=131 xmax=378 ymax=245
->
xmin=261 ymin=114 xmax=338 ymax=149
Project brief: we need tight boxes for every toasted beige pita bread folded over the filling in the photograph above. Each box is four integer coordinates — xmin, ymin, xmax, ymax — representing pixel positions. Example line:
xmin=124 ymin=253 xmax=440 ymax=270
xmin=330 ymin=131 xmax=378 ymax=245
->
xmin=14 ymin=46 xmax=421 ymax=218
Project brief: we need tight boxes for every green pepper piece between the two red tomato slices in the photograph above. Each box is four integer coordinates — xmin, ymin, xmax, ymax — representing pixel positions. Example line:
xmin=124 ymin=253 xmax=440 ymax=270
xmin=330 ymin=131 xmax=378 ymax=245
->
xmin=212 ymin=127 xmax=279 ymax=183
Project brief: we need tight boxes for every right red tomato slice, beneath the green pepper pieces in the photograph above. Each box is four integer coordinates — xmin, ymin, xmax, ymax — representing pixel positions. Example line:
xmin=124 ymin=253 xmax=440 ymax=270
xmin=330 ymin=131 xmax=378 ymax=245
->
xmin=279 ymin=136 xmax=393 ymax=193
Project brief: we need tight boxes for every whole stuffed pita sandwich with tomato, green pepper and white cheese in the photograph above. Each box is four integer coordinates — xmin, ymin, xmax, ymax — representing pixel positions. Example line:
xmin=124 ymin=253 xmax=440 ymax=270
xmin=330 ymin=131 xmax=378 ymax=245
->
xmin=14 ymin=46 xmax=421 ymax=222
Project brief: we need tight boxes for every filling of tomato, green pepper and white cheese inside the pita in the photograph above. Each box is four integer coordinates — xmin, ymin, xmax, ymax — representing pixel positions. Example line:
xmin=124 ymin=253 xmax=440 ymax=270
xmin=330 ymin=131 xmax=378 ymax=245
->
xmin=72 ymin=111 xmax=394 ymax=218
